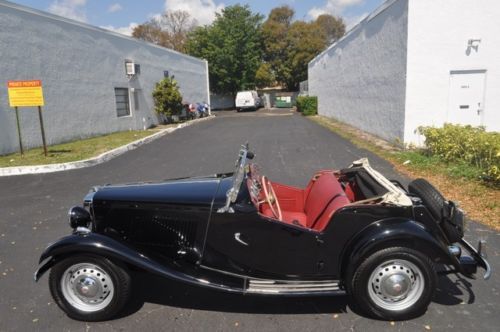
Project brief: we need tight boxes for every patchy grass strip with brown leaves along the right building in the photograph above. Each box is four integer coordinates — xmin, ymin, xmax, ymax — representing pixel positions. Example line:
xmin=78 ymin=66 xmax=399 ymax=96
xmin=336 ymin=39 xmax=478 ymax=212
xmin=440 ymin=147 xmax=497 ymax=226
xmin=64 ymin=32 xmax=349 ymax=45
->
xmin=308 ymin=116 xmax=500 ymax=230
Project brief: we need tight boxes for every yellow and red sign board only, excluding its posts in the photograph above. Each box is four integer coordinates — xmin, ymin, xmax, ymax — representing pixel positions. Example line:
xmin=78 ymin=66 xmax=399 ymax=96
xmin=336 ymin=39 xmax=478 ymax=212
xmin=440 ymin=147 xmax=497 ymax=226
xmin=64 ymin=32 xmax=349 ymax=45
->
xmin=7 ymin=80 xmax=44 ymax=107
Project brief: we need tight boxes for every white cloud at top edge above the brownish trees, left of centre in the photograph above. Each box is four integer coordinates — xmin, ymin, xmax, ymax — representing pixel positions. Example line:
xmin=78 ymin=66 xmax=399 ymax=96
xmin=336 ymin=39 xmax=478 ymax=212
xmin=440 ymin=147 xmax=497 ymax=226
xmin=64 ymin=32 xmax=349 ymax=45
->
xmin=165 ymin=0 xmax=225 ymax=25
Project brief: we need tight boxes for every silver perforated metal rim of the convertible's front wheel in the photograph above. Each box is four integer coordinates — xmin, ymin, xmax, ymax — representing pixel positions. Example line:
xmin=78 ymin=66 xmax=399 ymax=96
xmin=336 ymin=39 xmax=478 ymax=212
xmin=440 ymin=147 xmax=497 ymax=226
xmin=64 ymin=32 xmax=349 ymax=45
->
xmin=61 ymin=263 xmax=114 ymax=312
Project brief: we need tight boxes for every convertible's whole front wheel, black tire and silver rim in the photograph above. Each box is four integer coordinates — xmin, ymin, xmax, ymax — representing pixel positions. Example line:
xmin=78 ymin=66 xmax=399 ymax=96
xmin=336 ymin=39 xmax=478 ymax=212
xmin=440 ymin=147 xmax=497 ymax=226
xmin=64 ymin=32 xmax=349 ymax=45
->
xmin=49 ymin=255 xmax=131 ymax=321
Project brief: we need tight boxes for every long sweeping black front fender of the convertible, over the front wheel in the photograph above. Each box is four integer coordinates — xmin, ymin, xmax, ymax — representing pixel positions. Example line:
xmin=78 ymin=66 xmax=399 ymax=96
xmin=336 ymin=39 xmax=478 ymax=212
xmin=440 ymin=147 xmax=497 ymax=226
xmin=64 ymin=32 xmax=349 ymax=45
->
xmin=35 ymin=233 xmax=241 ymax=292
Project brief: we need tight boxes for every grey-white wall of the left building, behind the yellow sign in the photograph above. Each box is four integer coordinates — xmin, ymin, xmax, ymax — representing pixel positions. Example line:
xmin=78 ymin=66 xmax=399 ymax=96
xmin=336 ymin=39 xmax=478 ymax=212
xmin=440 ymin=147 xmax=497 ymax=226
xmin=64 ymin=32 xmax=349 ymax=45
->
xmin=0 ymin=0 xmax=210 ymax=154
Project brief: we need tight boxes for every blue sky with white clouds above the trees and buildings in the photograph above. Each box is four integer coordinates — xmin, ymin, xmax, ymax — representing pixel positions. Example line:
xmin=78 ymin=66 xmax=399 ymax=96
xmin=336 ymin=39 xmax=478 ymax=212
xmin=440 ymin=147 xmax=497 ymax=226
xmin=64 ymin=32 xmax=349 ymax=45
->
xmin=6 ymin=0 xmax=384 ymax=35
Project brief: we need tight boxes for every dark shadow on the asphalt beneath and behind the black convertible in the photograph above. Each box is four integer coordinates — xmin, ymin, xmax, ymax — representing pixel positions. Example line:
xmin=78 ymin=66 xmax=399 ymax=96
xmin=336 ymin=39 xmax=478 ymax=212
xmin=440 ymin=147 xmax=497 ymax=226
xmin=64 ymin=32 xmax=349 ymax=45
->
xmin=118 ymin=272 xmax=475 ymax=318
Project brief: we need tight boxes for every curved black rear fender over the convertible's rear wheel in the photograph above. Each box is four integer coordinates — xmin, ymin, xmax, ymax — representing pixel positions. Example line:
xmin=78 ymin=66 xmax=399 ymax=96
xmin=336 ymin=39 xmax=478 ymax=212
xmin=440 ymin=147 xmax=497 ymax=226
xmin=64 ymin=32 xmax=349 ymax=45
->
xmin=340 ymin=218 xmax=458 ymax=277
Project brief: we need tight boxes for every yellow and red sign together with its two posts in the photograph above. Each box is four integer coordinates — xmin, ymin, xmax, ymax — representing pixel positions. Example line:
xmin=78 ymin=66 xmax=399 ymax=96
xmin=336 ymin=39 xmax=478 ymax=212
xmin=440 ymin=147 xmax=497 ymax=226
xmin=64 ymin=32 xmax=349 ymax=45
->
xmin=7 ymin=80 xmax=47 ymax=156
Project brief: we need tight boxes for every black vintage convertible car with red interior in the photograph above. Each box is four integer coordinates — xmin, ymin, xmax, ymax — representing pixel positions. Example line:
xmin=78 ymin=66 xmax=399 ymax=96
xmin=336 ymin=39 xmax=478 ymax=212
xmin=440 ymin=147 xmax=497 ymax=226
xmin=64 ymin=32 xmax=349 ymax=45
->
xmin=35 ymin=145 xmax=491 ymax=321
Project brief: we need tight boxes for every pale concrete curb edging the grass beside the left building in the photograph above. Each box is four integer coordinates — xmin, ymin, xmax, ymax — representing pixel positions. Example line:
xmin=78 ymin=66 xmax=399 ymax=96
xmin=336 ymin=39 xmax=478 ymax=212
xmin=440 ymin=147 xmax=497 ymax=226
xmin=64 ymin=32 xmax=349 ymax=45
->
xmin=0 ymin=115 xmax=215 ymax=176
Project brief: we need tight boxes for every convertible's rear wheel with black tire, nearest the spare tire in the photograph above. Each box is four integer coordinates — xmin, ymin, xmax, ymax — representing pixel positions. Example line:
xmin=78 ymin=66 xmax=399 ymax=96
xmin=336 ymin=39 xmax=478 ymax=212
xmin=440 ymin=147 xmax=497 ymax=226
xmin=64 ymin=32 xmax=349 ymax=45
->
xmin=346 ymin=247 xmax=437 ymax=320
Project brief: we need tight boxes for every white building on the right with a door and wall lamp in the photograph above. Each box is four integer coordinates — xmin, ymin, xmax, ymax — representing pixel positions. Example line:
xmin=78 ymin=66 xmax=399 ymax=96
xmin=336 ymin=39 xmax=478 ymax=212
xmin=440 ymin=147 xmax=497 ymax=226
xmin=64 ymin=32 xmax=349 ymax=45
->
xmin=308 ymin=0 xmax=500 ymax=145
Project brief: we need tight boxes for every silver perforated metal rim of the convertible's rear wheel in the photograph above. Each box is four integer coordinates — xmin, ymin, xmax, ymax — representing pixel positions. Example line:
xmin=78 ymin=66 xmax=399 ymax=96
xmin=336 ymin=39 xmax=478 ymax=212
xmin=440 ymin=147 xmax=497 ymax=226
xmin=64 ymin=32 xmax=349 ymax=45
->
xmin=367 ymin=260 xmax=424 ymax=311
